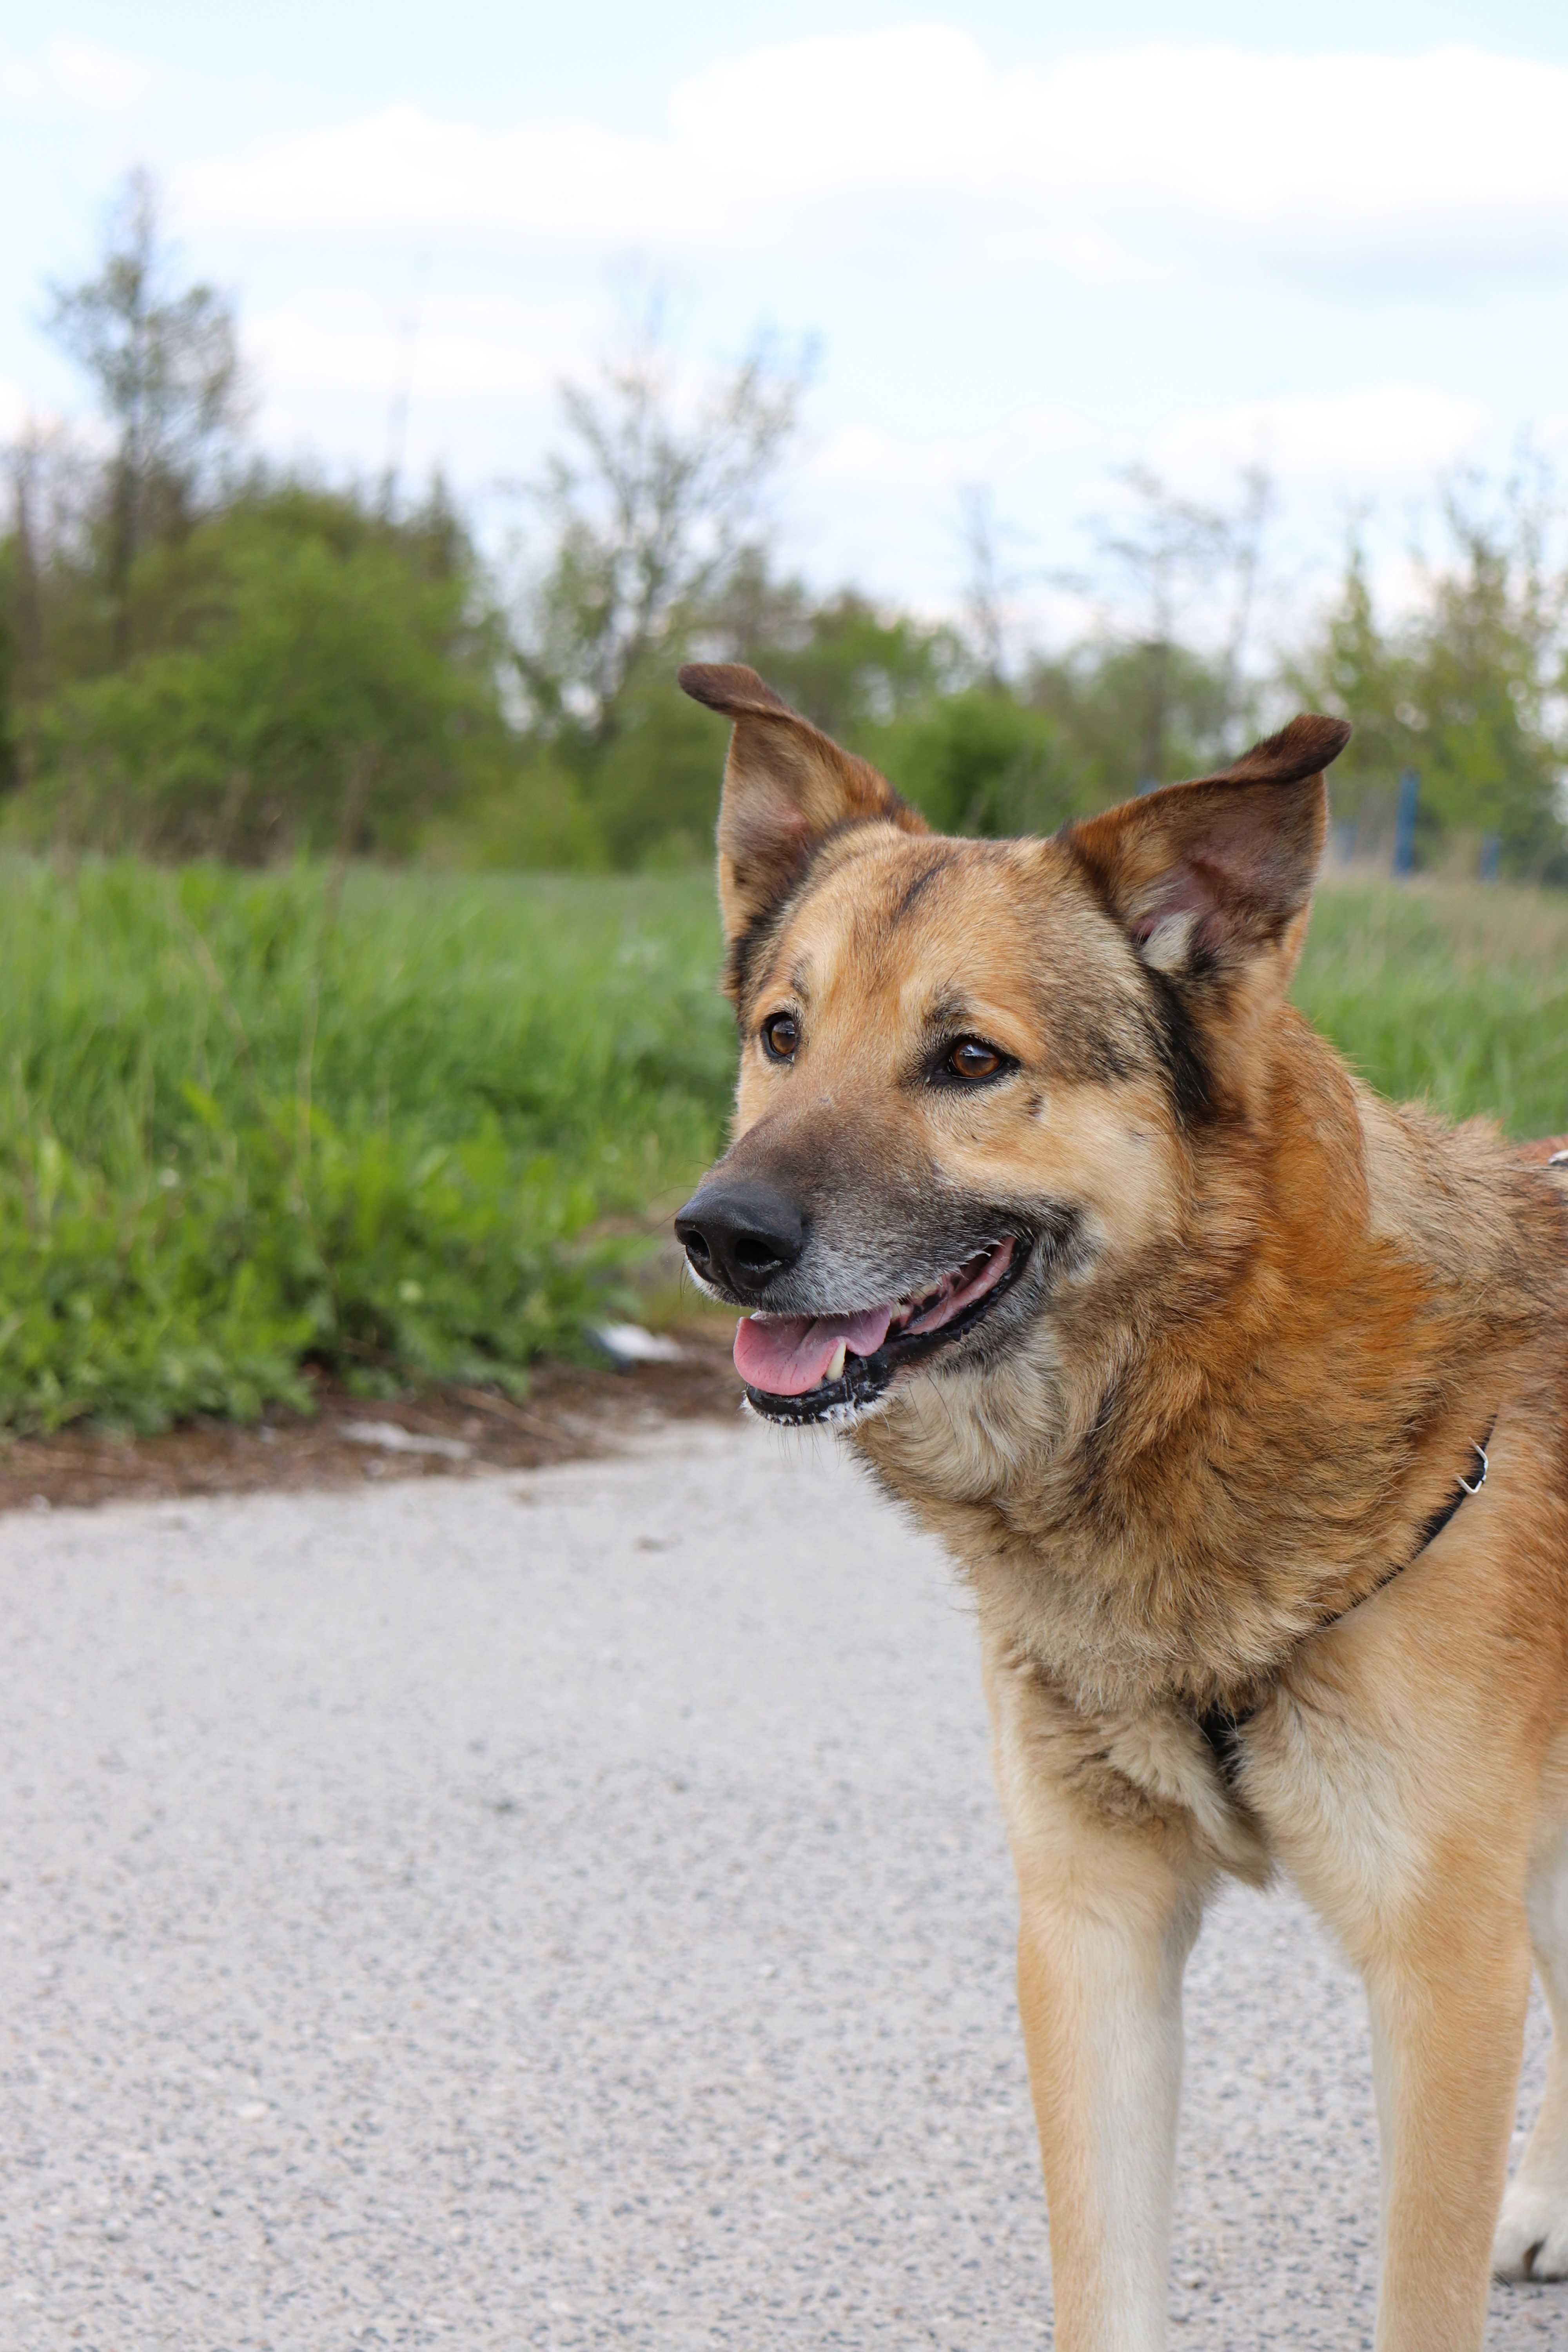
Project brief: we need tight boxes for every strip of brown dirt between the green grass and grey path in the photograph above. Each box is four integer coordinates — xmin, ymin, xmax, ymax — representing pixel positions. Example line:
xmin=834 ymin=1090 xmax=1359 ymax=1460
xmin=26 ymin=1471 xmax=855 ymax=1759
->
xmin=0 ymin=1331 xmax=740 ymax=1510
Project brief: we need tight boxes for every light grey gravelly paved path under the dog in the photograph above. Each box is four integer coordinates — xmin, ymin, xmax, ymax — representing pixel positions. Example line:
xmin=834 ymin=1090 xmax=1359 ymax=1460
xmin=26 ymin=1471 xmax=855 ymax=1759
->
xmin=0 ymin=1428 xmax=1568 ymax=2352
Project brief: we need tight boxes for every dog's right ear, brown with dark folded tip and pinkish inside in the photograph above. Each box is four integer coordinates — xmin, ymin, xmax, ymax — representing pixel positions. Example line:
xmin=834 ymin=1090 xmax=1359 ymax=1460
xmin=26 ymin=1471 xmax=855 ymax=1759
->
xmin=1063 ymin=713 xmax=1349 ymax=995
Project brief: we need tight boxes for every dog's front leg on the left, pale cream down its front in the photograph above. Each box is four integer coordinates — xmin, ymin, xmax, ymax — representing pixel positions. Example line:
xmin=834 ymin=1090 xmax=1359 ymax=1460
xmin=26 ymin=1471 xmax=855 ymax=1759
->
xmin=985 ymin=1649 xmax=1213 ymax=2352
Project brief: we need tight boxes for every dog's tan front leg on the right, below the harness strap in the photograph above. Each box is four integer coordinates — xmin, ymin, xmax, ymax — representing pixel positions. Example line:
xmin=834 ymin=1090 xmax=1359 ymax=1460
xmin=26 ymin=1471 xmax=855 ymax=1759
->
xmin=1241 ymin=1637 xmax=1540 ymax=2352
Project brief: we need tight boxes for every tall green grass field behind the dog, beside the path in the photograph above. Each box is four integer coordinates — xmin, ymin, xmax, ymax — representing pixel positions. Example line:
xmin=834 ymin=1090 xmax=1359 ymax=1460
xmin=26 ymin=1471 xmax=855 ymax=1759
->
xmin=0 ymin=863 xmax=1568 ymax=1428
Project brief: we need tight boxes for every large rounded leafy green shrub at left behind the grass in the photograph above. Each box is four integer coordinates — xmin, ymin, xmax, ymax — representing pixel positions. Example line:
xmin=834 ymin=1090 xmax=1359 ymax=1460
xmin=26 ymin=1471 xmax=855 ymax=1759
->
xmin=12 ymin=489 xmax=519 ymax=863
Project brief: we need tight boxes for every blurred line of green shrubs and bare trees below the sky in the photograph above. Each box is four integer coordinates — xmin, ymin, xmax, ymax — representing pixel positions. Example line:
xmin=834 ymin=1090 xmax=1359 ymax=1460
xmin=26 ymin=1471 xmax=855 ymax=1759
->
xmin=0 ymin=172 xmax=1568 ymax=882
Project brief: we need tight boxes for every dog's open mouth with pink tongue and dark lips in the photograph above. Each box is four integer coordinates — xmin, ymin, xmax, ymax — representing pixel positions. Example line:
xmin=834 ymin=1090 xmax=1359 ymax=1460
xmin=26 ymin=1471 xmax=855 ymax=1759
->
xmin=736 ymin=1235 xmax=1025 ymax=1423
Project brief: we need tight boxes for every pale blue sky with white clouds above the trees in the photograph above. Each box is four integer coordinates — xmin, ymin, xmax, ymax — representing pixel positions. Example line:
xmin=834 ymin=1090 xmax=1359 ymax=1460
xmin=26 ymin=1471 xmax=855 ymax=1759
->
xmin=0 ymin=0 xmax=1568 ymax=644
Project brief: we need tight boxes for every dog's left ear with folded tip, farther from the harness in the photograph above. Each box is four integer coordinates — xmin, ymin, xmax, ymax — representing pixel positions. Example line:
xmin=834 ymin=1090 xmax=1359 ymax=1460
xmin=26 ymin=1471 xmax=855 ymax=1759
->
xmin=679 ymin=661 xmax=926 ymax=946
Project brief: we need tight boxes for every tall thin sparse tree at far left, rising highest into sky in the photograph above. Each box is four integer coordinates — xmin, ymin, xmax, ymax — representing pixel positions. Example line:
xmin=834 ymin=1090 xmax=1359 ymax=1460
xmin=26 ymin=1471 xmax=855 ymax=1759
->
xmin=47 ymin=169 xmax=242 ymax=661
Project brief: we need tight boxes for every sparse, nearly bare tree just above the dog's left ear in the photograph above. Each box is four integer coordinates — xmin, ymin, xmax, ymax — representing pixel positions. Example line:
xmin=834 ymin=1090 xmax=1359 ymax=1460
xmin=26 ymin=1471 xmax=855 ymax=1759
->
xmin=517 ymin=327 xmax=804 ymax=741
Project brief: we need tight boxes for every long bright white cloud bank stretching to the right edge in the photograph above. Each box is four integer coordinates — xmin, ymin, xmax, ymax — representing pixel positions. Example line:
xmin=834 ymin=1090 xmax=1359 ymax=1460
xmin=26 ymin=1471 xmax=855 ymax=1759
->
xmin=183 ymin=26 xmax=1568 ymax=282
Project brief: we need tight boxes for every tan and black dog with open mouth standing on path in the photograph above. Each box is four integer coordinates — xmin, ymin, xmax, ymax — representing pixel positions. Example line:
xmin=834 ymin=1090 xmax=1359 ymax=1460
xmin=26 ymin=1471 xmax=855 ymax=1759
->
xmin=675 ymin=663 xmax=1568 ymax=2352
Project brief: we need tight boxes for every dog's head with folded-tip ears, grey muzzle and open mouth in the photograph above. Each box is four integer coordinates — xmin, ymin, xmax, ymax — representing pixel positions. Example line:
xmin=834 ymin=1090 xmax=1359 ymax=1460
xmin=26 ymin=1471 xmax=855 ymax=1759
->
xmin=675 ymin=663 xmax=1349 ymax=1423
